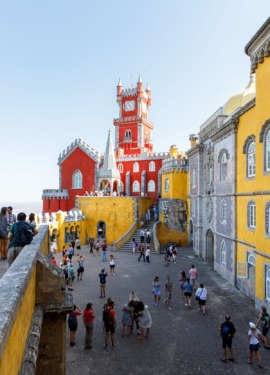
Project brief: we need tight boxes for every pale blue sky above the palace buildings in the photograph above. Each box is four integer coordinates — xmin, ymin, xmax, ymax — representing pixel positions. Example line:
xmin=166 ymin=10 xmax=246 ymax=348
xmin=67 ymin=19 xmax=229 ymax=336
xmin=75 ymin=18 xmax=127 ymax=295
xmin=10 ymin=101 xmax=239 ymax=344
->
xmin=0 ymin=0 xmax=270 ymax=206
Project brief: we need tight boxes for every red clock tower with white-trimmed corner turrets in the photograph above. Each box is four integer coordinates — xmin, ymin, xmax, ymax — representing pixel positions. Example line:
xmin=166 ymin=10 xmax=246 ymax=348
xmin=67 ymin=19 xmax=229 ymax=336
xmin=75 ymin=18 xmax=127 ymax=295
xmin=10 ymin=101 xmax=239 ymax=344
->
xmin=113 ymin=77 xmax=154 ymax=157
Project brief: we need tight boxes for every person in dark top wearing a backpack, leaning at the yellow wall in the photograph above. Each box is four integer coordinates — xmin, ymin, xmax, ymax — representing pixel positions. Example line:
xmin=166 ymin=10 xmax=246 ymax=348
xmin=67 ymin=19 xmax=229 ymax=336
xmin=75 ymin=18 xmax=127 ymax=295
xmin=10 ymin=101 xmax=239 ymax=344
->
xmin=7 ymin=212 xmax=38 ymax=267
